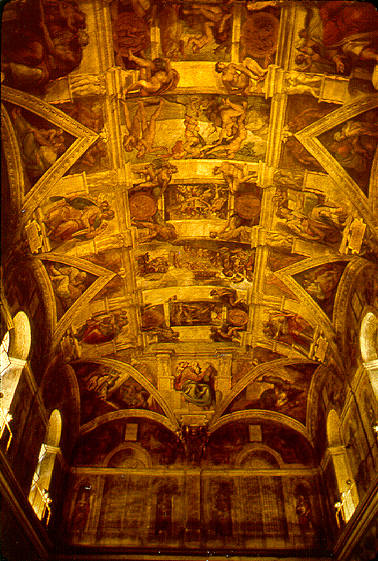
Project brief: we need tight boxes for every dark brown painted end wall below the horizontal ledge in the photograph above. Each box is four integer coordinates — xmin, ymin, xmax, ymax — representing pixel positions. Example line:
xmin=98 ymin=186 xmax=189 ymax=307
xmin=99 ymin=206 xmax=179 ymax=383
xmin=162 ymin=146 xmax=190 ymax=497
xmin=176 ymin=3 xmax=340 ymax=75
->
xmin=67 ymin=472 xmax=322 ymax=549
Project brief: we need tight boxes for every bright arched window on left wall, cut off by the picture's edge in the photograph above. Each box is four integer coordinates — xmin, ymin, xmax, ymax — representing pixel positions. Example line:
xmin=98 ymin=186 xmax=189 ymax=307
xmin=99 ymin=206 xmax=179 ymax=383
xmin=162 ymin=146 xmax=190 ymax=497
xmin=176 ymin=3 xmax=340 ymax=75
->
xmin=0 ymin=311 xmax=31 ymax=449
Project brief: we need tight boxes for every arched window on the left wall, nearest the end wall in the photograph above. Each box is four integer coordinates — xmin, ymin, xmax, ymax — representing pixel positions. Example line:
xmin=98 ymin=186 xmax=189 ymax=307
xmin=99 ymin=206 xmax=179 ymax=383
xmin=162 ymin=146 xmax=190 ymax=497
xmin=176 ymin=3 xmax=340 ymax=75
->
xmin=29 ymin=409 xmax=62 ymax=524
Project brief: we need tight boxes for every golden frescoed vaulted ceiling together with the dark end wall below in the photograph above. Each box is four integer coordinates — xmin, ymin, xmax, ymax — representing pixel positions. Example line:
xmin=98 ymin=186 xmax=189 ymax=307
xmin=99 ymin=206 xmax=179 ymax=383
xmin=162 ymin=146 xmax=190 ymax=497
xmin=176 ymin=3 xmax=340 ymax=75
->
xmin=1 ymin=0 xmax=378 ymax=549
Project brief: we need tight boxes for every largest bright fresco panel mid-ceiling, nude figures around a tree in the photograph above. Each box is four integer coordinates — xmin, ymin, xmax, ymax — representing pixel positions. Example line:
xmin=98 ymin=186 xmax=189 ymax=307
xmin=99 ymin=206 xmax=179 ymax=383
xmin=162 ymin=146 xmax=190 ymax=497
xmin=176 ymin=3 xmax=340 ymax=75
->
xmin=122 ymin=94 xmax=270 ymax=163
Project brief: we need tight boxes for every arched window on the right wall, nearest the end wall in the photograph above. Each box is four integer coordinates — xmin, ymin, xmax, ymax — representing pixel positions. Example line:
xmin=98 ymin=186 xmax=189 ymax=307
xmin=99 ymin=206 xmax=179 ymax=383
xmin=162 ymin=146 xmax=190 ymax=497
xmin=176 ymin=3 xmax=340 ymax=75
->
xmin=327 ymin=409 xmax=358 ymax=524
